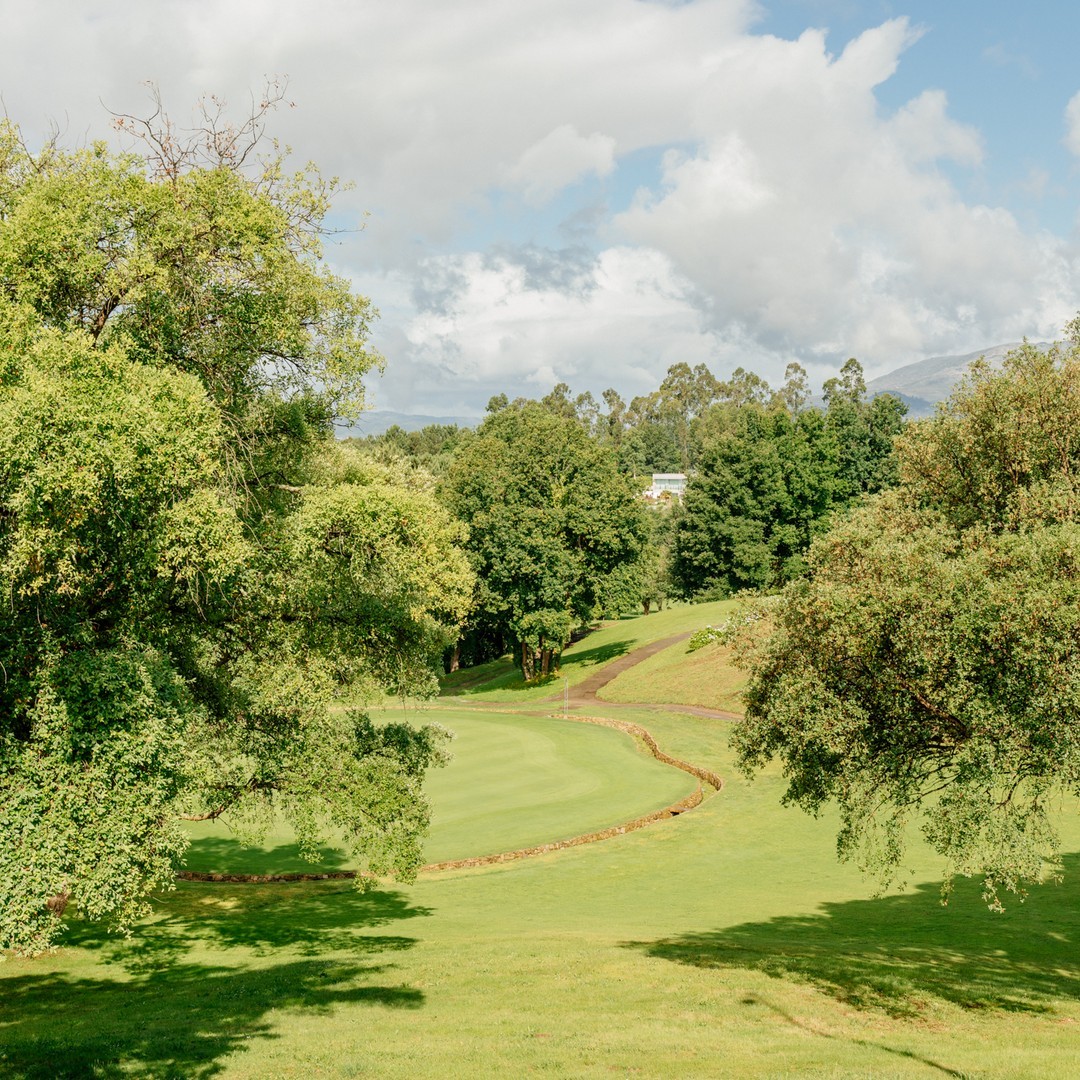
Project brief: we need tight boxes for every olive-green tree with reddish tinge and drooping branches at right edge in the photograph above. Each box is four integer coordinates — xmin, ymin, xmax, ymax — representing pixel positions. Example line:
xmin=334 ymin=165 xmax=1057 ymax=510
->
xmin=734 ymin=346 xmax=1080 ymax=906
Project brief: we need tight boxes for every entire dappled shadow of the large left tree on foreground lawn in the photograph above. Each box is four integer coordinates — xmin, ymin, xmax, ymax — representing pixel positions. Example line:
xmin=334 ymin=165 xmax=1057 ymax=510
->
xmin=0 ymin=881 xmax=431 ymax=1080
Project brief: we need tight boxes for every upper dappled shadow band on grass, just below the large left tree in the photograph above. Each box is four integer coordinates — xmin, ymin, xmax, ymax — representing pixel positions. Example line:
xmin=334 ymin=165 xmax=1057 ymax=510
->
xmin=64 ymin=881 xmax=431 ymax=975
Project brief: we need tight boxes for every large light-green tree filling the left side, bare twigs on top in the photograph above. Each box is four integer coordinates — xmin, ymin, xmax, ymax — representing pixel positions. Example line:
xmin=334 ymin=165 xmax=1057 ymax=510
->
xmin=0 ymin=103 xmax=472 ymax=951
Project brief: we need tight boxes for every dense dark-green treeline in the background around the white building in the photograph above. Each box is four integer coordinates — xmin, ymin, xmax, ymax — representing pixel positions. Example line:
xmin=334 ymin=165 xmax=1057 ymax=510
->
xmin=349 ymin=360 xmax=905 ymax=677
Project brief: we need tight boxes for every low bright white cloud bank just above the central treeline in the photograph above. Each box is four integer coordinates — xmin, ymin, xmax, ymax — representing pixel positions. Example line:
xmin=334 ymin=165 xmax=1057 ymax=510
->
xmin=362 ymin=247 xmax=751 ymax=411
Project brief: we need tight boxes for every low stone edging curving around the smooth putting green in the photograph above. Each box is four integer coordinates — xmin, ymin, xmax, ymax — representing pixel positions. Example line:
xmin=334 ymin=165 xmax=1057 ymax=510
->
xmin=176 ymin=713 xmax=724 ymax=885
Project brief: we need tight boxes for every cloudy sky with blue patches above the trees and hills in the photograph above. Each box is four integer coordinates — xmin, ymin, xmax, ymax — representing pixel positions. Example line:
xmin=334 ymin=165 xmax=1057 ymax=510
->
xmin=0 ymin=0 xmax=1080 ymax=417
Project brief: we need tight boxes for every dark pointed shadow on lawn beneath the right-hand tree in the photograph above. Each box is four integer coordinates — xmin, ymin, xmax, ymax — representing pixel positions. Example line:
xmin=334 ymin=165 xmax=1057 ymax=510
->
xmin=626 ymin=854 xmax=1080 ymax=1017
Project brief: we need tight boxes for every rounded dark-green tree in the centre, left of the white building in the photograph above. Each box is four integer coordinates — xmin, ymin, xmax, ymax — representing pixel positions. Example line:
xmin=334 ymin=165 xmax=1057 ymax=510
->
xmin=443 ymin=401 xmax=645 ymax=679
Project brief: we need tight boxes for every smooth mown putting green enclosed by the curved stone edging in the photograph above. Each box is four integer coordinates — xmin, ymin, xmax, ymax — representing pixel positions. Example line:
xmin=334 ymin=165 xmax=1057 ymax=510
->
xmin=187 ymin=710 xmax=697 ymax=874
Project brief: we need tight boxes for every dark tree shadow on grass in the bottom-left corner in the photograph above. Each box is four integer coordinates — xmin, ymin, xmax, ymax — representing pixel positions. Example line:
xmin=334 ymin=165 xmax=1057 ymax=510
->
xmin=0 ymin=960 xmax=423 ymax=1080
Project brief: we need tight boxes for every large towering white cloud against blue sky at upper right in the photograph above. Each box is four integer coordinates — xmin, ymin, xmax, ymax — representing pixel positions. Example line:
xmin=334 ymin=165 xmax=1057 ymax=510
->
xmin=618 ymin=19 xmax=1076 ymax=370
